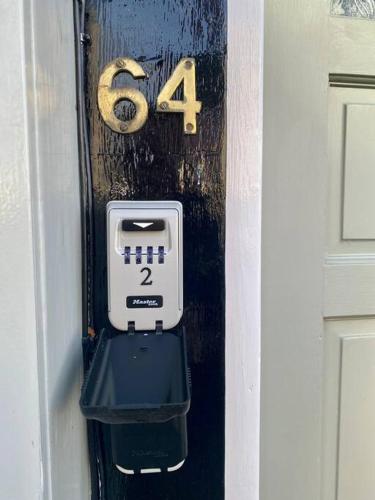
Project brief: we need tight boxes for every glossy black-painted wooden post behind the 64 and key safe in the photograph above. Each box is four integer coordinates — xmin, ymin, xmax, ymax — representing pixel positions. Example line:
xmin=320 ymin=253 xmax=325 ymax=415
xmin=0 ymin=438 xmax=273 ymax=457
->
xmin=82 ymin=0 xmax=226 ymax=500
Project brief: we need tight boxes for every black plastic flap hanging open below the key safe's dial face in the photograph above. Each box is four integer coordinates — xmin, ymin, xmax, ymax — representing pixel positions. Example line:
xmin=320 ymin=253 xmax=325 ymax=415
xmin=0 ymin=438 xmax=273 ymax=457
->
xmin=80 ymin=330 xmax=190 ymax=424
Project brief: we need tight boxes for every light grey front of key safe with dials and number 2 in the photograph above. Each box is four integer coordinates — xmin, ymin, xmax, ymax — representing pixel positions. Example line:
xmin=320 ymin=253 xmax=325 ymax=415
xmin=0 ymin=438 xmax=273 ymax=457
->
xmin=107 ymin=201 xmax=183 ymax=330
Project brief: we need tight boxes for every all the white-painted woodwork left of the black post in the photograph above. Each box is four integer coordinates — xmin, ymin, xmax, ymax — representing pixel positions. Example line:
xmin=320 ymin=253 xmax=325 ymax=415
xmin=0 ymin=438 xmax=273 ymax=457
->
xmin=0 ymin=0 xmax=89 ymax=500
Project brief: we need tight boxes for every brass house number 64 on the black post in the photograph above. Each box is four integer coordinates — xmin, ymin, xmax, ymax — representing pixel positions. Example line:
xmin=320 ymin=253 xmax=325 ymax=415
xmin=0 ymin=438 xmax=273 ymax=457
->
xmin=98 ymin=57 xmax=202 ymax=134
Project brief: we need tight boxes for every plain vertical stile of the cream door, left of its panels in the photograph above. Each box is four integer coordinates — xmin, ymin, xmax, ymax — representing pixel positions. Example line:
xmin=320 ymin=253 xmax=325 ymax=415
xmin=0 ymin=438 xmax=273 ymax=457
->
xmin=260 ymin=0 xmax=329 ymax=500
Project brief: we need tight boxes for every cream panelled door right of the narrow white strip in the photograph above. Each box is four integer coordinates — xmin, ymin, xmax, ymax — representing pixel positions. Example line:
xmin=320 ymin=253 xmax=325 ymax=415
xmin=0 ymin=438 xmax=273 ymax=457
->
xmin=260 ymin=0 xmax=375 ymax=500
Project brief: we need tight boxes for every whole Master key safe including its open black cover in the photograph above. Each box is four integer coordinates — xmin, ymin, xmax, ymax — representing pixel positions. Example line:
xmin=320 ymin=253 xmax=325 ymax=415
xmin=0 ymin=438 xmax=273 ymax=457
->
xmin=81 ymin=201 xmax=190 ymax=474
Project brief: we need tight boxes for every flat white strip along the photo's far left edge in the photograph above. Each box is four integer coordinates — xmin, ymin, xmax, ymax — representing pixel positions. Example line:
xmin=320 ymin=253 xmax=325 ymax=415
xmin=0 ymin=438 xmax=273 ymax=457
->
xmin=0 ymin=0 xmax=41 ymax=500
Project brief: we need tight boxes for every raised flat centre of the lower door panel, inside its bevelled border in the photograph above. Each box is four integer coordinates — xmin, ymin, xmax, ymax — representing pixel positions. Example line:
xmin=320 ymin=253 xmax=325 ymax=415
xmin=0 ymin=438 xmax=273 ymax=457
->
xmin=337 ymin=334 xmax=375 ymax=500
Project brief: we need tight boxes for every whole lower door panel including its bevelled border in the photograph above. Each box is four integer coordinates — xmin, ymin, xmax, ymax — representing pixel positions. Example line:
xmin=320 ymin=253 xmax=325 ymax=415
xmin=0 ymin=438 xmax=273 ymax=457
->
xmin=322 ymin=317 xmax=375 ymax=500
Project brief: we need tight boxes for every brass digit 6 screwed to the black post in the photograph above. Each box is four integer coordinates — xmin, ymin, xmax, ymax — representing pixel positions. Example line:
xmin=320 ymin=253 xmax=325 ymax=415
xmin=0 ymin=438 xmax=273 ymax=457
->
xmin=98 ymin=57 xmax=148 ymax=134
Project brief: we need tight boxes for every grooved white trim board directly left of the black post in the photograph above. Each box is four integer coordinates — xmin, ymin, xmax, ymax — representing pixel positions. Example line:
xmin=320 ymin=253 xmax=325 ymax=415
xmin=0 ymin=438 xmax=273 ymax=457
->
xmin=23 ymin=0 xmax=90 ymax=500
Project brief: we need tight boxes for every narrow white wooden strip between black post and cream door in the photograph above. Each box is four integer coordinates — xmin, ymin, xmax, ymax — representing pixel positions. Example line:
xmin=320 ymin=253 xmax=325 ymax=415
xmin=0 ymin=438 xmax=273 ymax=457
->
xmin=225 ymin=0 xmax=263 ymax=500
